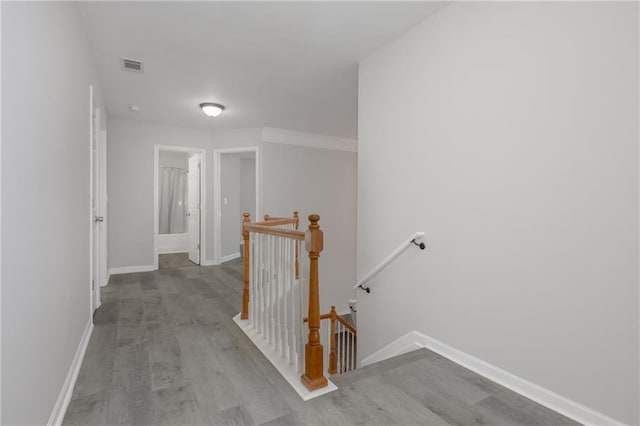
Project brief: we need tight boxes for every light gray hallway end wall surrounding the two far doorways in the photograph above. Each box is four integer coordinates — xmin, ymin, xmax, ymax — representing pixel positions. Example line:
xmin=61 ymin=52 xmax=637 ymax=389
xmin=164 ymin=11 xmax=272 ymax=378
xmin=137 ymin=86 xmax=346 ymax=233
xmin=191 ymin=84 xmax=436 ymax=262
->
xmin=107 ymin=118 xmax=261 ymax=268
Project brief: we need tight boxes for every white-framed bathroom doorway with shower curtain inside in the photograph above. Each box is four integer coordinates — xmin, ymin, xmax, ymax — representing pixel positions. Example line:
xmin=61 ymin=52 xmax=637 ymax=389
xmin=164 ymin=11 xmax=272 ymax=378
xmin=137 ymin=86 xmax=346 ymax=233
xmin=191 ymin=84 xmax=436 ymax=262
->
xmin=154 ymin=145 xmax=206 ymax=269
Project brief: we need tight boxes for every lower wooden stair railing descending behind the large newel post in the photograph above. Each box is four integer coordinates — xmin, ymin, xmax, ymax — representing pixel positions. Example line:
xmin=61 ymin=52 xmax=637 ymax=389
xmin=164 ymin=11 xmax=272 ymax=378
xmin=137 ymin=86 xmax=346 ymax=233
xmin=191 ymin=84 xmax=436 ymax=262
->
xmin=303 ymin=306 xmax=358 ymax=374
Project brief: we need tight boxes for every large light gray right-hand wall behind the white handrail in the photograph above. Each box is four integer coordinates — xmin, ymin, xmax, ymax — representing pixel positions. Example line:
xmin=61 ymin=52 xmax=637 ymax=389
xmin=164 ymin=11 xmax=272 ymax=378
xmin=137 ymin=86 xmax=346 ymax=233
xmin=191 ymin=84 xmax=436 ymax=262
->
xmin=358 ymin=2 xmax=640 ymax=424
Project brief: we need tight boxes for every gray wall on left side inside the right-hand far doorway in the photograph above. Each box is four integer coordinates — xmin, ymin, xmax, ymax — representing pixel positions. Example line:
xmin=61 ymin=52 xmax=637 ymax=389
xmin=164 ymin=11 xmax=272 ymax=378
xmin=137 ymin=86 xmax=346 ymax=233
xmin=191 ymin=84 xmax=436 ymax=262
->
xmin=220 ymin=154 xmax=242 ymax=257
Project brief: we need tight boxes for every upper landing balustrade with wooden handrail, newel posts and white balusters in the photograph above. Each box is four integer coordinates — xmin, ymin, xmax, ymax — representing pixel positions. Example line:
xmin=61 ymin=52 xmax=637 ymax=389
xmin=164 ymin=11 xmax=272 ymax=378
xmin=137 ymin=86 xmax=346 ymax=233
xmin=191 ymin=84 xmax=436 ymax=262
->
xmin=240 ymin=212 xmax=328 ymax=391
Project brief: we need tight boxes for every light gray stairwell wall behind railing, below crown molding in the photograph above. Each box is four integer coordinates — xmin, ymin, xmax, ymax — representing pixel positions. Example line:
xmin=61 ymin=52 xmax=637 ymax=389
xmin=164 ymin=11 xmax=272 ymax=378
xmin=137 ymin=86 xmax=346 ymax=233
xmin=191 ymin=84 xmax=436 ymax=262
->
xmin=261 ymin=143 xmax=357 ymax=313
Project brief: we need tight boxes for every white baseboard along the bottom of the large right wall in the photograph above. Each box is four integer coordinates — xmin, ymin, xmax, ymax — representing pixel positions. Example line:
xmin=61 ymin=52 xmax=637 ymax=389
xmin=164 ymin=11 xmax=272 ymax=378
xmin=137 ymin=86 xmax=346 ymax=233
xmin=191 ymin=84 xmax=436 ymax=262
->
xmin=362 ymin=330 xmax=624 ymax=426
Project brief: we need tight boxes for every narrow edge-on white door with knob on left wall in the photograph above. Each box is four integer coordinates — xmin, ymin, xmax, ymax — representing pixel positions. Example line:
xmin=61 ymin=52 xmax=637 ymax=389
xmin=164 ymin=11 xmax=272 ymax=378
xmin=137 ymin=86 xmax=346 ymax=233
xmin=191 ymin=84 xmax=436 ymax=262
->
xmin=91 ymin=102 xmax=104 ymax=311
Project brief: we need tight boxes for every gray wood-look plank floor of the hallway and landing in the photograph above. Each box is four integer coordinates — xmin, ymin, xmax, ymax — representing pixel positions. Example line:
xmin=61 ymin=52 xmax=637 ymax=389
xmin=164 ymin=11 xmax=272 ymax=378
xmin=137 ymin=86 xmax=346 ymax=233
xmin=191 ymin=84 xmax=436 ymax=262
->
xmin=64 ymin=260 xmax=576 ymax=426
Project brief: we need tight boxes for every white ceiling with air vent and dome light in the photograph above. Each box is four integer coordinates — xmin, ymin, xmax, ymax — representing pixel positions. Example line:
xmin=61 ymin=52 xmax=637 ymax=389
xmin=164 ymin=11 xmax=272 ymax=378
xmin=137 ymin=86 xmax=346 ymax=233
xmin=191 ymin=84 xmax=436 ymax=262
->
xmin=80 ymin=1 xmax=443 ymax=139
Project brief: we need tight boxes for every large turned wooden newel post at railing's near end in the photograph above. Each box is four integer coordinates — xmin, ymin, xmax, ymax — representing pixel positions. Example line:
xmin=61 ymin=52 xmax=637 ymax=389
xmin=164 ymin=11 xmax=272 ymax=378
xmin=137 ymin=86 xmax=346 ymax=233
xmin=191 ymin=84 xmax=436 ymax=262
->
xmin=300 ymin=214 xmax=327 ymax=390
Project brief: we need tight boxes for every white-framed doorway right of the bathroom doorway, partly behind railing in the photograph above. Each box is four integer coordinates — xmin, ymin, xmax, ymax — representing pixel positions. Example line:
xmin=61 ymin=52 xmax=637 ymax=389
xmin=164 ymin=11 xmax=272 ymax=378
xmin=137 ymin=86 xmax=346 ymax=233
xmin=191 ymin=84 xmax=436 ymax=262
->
xmin=214 ymin=147 xmax=260 ymax=264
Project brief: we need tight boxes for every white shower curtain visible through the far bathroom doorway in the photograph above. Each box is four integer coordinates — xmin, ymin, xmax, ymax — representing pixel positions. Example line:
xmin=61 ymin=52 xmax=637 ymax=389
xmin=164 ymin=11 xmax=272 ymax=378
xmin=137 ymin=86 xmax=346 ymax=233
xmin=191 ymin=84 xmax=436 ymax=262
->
xmin=159 ymin=167 xmax=187 ymax=234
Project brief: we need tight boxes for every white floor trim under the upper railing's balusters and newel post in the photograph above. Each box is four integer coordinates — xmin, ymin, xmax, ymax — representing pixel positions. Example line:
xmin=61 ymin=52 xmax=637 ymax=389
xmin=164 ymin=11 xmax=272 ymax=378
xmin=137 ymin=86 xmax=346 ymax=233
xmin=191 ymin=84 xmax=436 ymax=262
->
xmin=233 ymin=314 xmax=338 ymax=401
